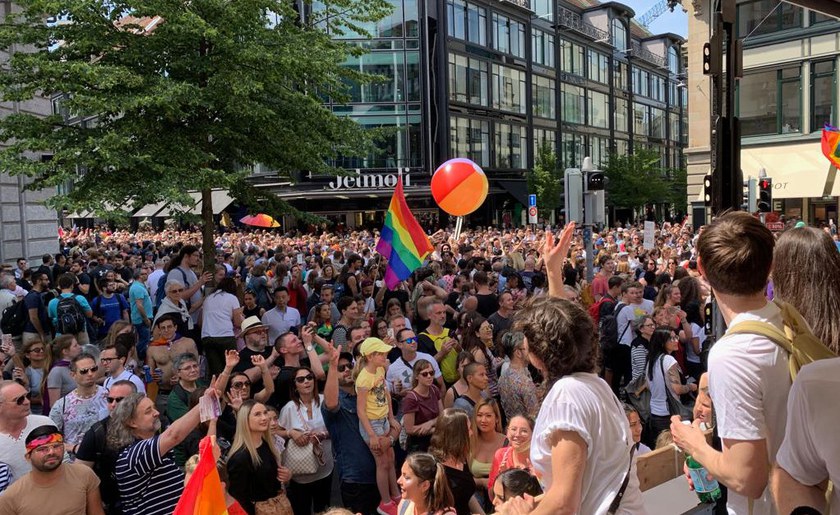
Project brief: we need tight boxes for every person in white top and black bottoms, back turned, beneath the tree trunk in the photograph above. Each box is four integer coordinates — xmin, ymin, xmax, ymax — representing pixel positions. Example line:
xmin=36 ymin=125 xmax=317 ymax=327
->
xmin=201 ymin=277 xmax=243 ymax=376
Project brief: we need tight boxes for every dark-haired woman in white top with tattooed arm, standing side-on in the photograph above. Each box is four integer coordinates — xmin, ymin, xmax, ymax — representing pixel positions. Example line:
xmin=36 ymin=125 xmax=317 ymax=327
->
xmin=645 ymin=326 xmax=697 ymax=440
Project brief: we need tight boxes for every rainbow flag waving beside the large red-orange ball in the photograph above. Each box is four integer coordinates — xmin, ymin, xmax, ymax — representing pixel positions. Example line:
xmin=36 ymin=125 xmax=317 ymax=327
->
xmin=376 ymin=181 xmax=434 ymax=290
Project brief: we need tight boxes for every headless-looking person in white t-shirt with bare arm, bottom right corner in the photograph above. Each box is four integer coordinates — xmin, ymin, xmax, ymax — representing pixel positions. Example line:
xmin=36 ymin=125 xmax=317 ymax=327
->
xmin=771 ymin=358 xmax=840 ymax=514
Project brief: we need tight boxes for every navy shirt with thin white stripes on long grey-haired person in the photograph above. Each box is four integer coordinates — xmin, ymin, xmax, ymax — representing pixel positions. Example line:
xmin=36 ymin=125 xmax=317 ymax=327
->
xmin=115 ymin=435 xmax=184 ymax=515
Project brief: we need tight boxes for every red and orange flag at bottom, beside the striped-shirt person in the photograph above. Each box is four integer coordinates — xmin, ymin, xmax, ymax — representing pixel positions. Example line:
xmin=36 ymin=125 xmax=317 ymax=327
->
xmin=172 ymin=436 xmax=228 ymax=515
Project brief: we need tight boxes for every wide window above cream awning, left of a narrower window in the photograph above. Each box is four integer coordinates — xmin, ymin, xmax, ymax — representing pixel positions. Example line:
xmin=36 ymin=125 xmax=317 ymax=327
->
xmin=738 ymin=65 xmax=802 ymax=136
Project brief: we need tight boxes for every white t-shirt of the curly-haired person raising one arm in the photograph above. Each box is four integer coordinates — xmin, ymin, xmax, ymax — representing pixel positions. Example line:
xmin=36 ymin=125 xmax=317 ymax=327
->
xmin=531 ymin=372 xmax=645 ymax=515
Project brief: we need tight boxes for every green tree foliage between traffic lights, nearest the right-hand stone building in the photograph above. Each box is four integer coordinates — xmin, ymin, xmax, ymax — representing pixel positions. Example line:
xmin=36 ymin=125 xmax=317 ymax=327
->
xmin=604 ymin=149 xmax=686 ymax=214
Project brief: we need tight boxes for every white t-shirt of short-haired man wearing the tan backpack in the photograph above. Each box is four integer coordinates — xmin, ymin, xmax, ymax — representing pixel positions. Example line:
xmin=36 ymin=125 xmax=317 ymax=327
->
xmin=709 ymin=302 xmax=791 ymax=515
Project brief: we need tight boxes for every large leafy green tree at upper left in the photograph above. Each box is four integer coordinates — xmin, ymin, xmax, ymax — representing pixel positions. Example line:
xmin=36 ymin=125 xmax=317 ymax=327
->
xmin=0 ymin=0 xmax=390 ymax=262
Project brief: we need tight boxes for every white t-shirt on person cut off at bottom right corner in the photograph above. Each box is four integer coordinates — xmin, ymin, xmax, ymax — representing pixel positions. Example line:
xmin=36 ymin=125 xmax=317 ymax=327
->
xmin=776 ymin=358 xmax=840 ymax=515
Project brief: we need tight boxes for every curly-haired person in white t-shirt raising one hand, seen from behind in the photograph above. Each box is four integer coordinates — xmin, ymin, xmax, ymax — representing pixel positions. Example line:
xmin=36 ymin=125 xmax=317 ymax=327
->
xmin=498 ymin=223 xmax=644 ymax=515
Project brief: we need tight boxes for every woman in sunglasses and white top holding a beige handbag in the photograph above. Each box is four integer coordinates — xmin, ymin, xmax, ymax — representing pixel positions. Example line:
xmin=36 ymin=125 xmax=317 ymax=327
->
xmin=280 ymin=367 xmax=333 ymax=513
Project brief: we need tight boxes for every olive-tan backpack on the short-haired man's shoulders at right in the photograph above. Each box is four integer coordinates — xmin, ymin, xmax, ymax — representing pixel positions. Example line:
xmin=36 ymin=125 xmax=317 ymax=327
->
xmin=726 ymin=299 xmax=837 ymax=381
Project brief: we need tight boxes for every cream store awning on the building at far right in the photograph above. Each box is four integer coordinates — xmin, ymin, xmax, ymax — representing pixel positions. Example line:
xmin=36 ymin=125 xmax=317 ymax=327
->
xmin=741 ymin=141 xmax=837 ymax=199
